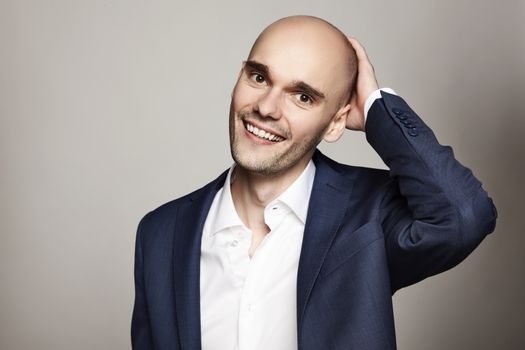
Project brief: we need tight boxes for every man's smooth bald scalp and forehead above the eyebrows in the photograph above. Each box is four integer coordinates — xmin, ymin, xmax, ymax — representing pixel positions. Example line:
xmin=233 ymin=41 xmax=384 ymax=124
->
xmin=248 ymin=16 xmax=357 ymax=104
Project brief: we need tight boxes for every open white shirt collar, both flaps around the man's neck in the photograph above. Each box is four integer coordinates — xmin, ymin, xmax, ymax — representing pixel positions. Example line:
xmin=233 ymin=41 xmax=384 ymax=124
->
xmin=210 ymin=159 xmax=315 ymax=236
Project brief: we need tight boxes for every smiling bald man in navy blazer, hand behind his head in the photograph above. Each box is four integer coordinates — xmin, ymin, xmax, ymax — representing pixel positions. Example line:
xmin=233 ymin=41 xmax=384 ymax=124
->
xmin=132 ymin=16 xmax=496 ymax=350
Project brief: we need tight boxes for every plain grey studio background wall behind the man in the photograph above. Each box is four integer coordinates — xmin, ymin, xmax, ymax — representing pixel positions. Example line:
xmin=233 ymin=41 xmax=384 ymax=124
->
xmin=0 ymin=0 xmax=525 ymax=349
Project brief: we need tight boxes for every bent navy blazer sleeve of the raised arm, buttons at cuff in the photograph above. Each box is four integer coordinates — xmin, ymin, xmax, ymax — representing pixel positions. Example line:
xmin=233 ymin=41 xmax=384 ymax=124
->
xmin=365 ymin=92 xmax=497 ymax=293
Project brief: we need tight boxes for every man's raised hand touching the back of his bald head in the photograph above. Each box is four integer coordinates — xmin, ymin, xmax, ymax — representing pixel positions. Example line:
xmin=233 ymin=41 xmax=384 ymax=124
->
xmin=346 ymin=37 xmax=379 ymax=131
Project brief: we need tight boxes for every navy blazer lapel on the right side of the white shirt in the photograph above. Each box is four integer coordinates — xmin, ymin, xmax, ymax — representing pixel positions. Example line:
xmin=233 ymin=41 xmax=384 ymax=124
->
xmin=297 ymin=151 xmax=353 ymax=335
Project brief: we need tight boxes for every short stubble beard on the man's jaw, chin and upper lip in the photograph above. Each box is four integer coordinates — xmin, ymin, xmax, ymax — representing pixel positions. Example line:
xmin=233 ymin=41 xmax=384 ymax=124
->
xmin=229 ymin=100 xmax=324 ymax=176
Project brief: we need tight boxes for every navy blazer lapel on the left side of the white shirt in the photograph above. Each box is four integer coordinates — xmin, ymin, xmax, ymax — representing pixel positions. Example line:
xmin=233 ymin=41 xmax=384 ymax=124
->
xmin=173 ymin=171 xmax=227 ymax=349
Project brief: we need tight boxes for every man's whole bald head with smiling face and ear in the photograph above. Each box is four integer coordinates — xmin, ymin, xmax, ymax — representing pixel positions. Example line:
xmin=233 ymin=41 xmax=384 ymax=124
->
xmin=230 ymin=17 xmax=355 ymax=175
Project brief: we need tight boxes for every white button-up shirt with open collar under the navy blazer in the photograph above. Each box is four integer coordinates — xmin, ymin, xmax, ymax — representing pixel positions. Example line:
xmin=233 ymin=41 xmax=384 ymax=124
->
xmin=200 ymin=160 xmax=315 ymax=350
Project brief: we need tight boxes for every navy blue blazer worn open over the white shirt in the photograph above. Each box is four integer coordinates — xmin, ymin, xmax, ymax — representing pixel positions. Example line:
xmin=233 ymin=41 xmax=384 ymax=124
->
xmin=131 ymin=92 xmax=496 ymax=350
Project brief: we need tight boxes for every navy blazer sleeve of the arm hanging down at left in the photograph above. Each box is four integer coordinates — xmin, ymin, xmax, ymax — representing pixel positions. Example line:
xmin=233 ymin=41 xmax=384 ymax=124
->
xmin=131 ymin=215 xmax=153 ymax=350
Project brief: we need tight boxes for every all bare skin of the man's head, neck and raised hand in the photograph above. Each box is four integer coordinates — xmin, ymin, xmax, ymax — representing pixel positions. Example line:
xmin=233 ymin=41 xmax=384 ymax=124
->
xmin=230 ymin=16 xmax=377 ymax=256
